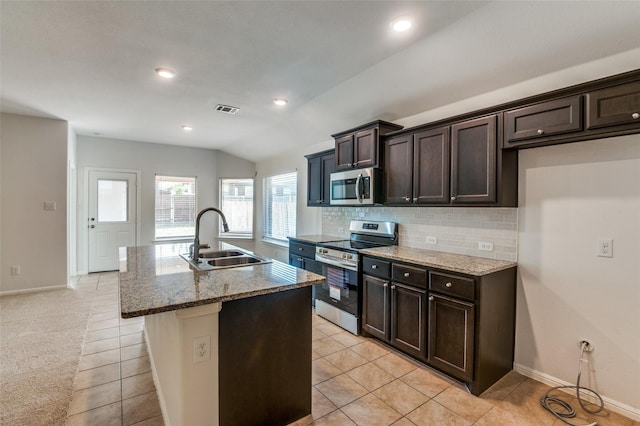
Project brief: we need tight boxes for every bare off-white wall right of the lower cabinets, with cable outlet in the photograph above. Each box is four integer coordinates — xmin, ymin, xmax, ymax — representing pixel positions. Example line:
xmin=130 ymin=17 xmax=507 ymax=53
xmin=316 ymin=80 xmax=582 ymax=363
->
xmin=515 ymin=135 xmax=640 ymax=414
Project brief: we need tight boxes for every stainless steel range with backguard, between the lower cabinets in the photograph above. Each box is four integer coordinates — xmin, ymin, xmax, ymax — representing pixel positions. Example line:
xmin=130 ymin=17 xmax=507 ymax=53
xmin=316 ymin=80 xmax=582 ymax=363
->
xmin=315 ymin=220 xmax=398 ymax=334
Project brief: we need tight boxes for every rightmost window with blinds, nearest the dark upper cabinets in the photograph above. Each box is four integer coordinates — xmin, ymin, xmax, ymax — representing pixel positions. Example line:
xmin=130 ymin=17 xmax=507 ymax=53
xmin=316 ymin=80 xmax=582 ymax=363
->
xmin=262 ymin=172 xmax=297 ymax=243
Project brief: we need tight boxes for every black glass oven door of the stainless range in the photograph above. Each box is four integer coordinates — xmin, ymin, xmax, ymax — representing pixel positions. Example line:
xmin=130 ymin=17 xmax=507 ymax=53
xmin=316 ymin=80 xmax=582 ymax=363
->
xmin=315 ymin=263 xmax=360 ymax=317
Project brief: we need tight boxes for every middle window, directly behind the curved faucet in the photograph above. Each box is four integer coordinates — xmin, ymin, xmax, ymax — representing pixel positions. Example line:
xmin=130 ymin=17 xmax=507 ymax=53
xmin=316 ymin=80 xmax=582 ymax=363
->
xmin=218 ymin=178 xmax=253 ymax=238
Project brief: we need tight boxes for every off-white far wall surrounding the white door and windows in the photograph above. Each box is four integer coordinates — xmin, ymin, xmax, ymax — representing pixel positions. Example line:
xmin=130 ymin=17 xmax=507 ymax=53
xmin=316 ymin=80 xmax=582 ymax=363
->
xmin=77 ymin=136 xmax=255 ymax=273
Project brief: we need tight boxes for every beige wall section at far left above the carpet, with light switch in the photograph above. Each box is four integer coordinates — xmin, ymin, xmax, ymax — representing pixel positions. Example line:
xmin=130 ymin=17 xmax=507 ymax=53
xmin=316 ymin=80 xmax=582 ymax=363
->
xmin=0 ymin=114 xmax=68 ymax=293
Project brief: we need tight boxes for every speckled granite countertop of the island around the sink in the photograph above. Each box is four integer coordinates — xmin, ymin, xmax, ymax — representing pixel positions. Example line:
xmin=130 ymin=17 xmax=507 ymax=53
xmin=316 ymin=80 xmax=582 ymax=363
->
xmin=120 ymin=241 xmax=324 ymax=318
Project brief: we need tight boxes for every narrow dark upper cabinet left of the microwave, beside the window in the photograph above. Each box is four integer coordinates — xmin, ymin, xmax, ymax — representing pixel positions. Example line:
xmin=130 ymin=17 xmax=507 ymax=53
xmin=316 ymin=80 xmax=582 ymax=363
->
xmin=306 ymin=149 xmax=336 ymax=207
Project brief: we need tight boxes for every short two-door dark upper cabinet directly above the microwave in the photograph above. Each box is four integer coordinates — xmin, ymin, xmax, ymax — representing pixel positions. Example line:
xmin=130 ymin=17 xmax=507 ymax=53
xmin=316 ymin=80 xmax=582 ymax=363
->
xmin=332 ymin=120 xmax=402 ymax=170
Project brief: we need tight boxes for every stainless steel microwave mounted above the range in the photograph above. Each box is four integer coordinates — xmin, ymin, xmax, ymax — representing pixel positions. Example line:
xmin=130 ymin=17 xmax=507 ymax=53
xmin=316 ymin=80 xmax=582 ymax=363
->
xmin=330 ymin=167 xmax=382 ymax=206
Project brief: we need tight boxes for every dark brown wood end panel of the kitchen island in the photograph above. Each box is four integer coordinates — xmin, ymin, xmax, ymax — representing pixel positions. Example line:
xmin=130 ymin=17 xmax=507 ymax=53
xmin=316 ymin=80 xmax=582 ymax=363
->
xmin=219 ymin=287 xmax=311 ymax=426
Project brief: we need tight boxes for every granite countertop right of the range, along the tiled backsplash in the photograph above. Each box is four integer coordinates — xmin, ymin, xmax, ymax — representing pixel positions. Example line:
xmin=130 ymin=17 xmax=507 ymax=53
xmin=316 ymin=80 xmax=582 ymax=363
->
xmin=360 ymin=246 xmax=517 ymax=276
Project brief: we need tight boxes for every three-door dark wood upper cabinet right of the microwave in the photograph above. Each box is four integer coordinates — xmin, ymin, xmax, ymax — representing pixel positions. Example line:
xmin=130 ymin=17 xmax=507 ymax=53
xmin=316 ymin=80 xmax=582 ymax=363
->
xmin=384 ymin=114 xmax=518 ymax=207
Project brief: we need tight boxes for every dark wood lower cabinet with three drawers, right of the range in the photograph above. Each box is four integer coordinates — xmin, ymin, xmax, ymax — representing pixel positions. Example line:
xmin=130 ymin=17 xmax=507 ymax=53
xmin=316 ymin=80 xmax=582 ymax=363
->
xmin=362 ymin=255 xmax=516 ymax=395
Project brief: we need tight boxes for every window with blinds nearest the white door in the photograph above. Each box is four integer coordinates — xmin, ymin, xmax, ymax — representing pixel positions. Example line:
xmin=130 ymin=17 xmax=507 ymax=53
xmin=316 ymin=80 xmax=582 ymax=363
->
xmin=156 ymin=175 xmax=197 ymax=238
